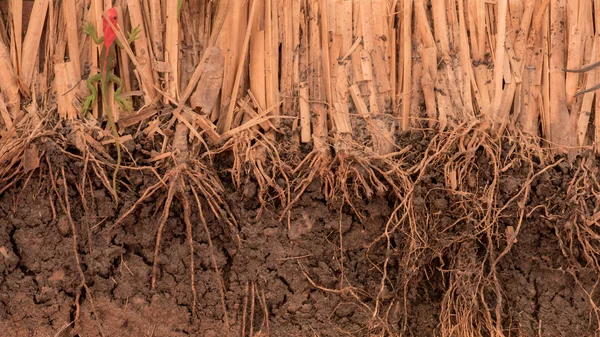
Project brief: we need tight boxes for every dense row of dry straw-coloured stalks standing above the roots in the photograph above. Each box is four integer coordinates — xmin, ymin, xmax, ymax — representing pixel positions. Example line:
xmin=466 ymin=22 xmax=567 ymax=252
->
xmin=0 ymin=0 xmax=598 ymax=155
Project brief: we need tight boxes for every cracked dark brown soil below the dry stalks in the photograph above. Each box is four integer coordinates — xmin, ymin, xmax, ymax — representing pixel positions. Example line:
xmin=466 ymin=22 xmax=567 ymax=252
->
xmin=0 ymin=129 xmax=600 ymax=337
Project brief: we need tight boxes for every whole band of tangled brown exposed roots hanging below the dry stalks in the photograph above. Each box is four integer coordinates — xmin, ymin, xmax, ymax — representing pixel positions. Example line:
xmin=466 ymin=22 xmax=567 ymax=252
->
xmin=0 ymin=106 xmax=600 ymax=337
